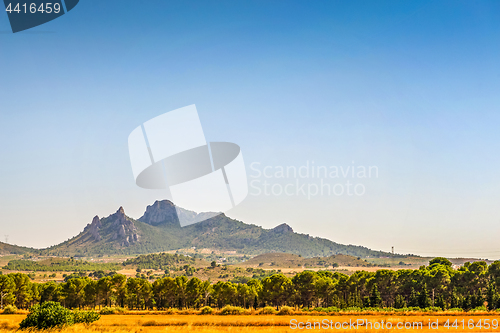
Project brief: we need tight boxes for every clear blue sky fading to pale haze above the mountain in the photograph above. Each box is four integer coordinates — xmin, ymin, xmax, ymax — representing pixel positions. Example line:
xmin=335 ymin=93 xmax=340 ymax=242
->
xmin=0 ymin=0 xmax=500 ymax=259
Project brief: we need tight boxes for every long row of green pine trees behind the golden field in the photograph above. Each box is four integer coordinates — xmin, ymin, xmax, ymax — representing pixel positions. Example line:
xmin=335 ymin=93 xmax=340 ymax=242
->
xmin=0 ymin=258 xmax=500 ymax=310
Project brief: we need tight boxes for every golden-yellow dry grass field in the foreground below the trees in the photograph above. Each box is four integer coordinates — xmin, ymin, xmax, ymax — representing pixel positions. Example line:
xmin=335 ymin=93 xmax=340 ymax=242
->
xmin=0 ymin=314 xmax=500 ymax=333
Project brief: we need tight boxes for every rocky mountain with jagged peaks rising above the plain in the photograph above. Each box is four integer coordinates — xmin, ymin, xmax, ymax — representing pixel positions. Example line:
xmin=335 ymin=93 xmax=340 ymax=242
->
xmin=39 ymin=200 xmax=389 ymax=257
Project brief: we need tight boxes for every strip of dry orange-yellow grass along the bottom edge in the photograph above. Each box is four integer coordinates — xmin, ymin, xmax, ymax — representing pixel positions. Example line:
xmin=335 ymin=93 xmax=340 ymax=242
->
xmin=0 ymin=314 xmax=500 ymax=333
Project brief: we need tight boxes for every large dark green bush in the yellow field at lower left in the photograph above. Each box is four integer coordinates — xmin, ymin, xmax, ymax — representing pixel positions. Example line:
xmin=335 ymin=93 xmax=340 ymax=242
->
xmin=19 ymin=302 xmax=99 ymax=329
